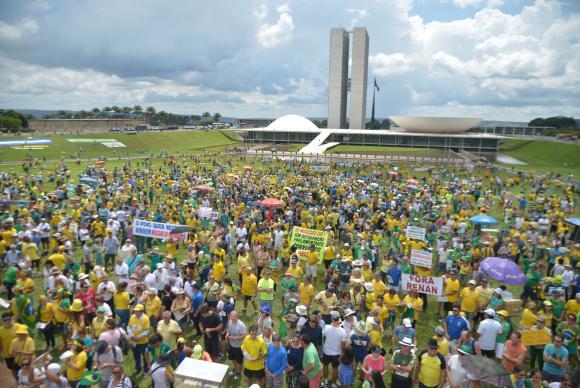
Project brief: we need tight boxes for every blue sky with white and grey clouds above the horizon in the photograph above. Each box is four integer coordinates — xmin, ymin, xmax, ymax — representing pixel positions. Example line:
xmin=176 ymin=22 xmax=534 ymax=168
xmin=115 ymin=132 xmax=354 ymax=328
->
xmin=0 ymin=0 xmax=580 ymax=120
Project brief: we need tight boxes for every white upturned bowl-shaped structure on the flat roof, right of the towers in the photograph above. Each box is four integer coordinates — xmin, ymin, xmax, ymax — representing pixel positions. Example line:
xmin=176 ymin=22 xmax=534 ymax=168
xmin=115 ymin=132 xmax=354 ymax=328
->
xmin=390 ymin=116 xmax=483 ymax=133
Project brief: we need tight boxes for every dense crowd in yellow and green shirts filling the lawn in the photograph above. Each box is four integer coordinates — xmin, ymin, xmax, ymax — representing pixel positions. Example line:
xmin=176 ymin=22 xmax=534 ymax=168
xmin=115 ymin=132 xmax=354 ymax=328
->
xmin=0 ymin=157 xmax=580 ymax=388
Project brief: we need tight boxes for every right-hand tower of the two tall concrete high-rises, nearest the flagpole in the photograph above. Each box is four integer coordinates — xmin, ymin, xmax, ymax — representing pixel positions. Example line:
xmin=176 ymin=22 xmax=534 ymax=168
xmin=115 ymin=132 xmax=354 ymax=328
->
xmin=348 ymin=27 xmax=369 ymax=129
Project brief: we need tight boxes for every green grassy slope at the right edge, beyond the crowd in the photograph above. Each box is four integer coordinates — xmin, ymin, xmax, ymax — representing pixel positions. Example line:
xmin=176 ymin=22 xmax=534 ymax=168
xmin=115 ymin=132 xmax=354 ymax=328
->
xmin=500 ymin=140 xmax=580 ymax=177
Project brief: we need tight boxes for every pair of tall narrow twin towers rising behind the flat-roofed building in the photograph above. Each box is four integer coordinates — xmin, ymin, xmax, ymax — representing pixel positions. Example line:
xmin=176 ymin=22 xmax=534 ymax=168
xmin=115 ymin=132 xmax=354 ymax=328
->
xmin=327 ymin=27 xmax=369 ymax=129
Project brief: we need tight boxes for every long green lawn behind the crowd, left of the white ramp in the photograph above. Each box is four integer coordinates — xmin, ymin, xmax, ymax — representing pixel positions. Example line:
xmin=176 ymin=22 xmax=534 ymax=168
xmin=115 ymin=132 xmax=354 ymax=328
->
xmin=0 ymin=131 xmax=238 ymax=161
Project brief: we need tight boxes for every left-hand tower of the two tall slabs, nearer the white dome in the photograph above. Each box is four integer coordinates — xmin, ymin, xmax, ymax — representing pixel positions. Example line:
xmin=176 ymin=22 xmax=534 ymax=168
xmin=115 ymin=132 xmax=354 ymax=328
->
xmin=328 ymin=28 xmax=349 ymax=128
